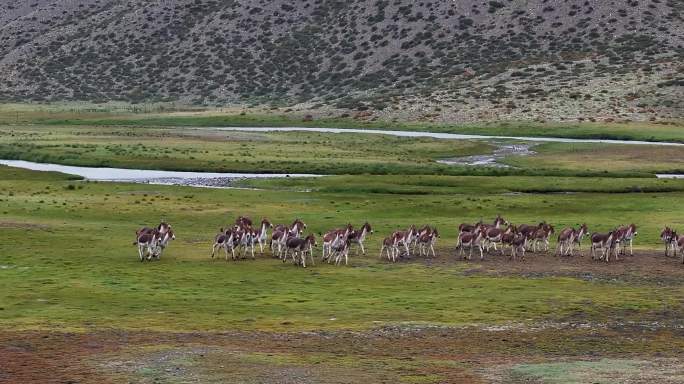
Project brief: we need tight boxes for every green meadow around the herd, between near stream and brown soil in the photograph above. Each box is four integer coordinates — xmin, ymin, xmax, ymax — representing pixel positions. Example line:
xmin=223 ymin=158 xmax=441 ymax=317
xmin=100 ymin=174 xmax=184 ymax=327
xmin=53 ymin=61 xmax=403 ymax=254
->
xmin=0 ymin=167 xmax=684 ymax=331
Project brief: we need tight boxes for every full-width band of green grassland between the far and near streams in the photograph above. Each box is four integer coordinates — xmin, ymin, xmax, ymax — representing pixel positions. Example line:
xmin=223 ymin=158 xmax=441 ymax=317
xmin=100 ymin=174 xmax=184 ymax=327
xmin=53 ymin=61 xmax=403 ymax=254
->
xmin=0 ymin=125 xmax=684 ymax=177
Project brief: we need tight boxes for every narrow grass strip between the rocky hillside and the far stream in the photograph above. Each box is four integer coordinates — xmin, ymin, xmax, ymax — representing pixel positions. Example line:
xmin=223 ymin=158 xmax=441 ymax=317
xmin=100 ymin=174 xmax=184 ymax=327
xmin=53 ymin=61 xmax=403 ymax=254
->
xmin=0 ymin=103 xmax=684 ymax=142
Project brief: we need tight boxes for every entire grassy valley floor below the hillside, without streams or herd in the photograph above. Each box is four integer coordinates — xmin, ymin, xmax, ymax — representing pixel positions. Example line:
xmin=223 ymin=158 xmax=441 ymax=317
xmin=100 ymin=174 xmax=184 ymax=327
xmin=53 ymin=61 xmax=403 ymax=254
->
xmin=0 ymin=106 xmax=684 ymax=383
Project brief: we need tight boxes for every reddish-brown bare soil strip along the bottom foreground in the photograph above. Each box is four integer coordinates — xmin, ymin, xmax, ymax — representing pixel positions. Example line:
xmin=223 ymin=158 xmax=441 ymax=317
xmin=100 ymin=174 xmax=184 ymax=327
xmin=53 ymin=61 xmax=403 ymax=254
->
xmin=0 ymin=326 xmax=684 ymax=383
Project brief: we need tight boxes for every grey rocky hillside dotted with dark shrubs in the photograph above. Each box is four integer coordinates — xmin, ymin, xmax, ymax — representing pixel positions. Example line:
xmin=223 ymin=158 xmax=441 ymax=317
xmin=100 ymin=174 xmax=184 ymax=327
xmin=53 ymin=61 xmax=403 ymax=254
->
xmin=0 ymin=0 xmax=684 ymax=121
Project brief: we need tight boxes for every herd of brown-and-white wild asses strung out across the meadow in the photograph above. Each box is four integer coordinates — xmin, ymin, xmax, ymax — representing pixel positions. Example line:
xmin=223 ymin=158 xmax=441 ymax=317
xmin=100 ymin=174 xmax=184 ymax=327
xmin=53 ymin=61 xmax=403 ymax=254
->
xmin=133 ymin=215 xmax=684 ymax=267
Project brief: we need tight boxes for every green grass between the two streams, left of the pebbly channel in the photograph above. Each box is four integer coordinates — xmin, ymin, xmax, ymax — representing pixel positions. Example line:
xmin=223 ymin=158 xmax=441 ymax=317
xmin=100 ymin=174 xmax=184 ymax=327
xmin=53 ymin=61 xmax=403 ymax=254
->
xmin=0 ymin=126 xmax=493 ymax=174
